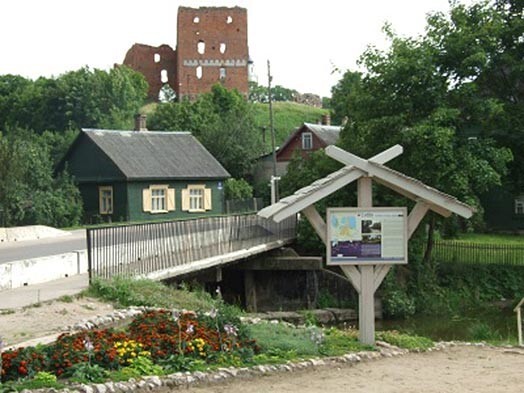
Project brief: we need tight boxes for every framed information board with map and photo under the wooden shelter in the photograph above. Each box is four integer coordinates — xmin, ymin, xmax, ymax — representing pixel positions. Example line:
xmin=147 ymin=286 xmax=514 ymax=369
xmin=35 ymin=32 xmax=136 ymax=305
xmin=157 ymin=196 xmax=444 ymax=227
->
xmin=327 ymin=207 xmax=407 ymax=265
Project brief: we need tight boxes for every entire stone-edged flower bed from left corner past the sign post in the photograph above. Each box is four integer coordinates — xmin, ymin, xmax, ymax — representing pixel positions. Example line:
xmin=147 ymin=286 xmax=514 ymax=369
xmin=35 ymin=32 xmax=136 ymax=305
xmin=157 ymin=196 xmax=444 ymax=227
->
xmin=0 ymin=303 xmax=433 ymax=392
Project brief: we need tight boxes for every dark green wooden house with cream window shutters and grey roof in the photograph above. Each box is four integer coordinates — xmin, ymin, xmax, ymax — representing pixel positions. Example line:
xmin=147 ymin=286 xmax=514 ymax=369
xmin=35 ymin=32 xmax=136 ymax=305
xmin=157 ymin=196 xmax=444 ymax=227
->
xmin=58 ymin=129 xmax=230 ymax=222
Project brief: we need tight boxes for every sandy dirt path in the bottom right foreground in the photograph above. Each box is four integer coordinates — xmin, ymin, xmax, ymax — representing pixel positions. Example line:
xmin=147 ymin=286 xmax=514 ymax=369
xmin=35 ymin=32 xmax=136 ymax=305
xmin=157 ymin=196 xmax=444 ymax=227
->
xmin=184 ymin=347 xmax=524 ymax=393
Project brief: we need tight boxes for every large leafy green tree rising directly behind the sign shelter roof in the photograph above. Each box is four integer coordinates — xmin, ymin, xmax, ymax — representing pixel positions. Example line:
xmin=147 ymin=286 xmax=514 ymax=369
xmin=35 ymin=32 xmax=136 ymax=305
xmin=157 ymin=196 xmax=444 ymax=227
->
xmin=333 ymin=3 xmax=511 ymax=217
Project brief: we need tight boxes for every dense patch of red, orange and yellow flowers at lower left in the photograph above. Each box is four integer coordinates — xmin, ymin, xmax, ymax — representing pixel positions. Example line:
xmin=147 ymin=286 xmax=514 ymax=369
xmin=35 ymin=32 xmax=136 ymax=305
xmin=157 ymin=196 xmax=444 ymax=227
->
xmin=0 ymin=310 xmax=258 ymax=382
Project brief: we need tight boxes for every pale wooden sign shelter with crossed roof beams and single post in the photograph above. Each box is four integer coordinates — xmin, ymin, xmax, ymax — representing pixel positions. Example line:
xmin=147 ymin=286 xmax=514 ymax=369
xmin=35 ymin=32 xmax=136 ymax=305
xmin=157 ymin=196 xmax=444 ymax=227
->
xmin=258 ymin=145 xmax=475 ymax=344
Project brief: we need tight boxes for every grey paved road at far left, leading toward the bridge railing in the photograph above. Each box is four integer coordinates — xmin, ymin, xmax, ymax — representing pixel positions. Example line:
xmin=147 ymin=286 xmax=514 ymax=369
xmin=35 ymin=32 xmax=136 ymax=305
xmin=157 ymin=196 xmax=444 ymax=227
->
xmin=0 ymin=229 xmax=86 ymax=264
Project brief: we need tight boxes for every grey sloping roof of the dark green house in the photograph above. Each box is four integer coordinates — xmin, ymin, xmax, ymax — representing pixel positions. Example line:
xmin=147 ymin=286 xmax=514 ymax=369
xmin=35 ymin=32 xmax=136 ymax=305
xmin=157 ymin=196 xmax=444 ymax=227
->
xmin=82 ymin=129 xmax=231 ymax=180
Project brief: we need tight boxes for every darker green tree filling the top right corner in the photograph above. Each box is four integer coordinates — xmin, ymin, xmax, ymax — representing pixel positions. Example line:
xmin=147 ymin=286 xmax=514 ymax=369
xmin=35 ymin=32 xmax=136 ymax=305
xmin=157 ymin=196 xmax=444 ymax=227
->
xmin=427 ymin=0 xmax=524 ymax=191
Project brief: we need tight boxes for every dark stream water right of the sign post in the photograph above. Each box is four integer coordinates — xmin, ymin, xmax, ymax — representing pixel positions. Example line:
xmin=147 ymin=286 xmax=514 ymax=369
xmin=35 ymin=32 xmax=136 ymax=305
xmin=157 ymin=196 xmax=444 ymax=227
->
xmin=376 ymin=307 xmax=517 ymax=342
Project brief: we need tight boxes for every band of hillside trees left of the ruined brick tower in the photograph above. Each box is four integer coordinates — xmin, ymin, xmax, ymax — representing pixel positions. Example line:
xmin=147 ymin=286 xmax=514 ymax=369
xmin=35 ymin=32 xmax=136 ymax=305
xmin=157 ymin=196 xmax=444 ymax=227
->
xmin=0 ymin=66 xmax=147 ymax=134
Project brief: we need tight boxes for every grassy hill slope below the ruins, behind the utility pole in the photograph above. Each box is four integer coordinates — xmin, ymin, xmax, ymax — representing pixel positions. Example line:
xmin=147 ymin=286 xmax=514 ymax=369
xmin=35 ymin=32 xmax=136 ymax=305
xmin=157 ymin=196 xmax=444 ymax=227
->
xmin=253 ymin=101 xmax=328 ymax=147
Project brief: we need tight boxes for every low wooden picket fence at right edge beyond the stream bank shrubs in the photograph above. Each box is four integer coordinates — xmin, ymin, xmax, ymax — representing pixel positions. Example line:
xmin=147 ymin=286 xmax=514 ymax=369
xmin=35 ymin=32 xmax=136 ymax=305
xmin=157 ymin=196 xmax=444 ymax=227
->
xmin=433 ymin=240 xmax=524 ymax=266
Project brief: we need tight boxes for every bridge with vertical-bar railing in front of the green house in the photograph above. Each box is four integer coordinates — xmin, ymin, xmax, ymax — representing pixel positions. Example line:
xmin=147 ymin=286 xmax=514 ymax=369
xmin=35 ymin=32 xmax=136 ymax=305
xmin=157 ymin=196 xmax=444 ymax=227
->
xmin=87 ymin=214 xmax=296 ymax=282
